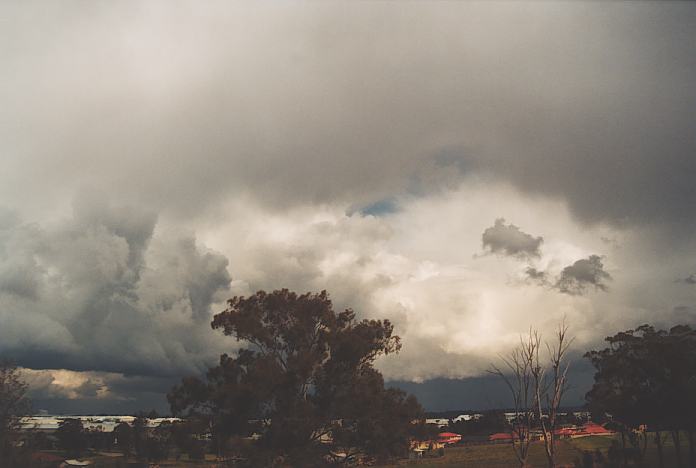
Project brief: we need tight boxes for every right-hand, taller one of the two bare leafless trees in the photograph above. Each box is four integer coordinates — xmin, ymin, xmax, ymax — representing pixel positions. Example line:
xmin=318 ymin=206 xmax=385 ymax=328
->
xmin=532 ymin=320 xmax=573 ymax=468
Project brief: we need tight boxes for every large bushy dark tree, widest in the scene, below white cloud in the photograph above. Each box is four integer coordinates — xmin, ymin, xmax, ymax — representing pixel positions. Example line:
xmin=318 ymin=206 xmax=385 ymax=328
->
xmin=168 ymin=289 xmax=422 ymax=466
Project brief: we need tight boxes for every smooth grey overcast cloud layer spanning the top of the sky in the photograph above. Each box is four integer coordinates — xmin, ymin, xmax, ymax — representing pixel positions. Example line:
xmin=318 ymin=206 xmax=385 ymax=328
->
xmin=0 ymin=2 xmax=696 ymax=236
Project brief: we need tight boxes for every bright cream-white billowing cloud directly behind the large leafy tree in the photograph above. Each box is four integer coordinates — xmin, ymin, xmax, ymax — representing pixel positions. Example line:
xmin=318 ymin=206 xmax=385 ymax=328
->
xmin=201 ymin=181 xmax=660 ymax=380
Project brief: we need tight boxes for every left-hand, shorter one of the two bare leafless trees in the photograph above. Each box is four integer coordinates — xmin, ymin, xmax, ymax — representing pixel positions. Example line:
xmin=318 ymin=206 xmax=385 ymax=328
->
xmin=489 ymin=328 xmax=541 ymax=467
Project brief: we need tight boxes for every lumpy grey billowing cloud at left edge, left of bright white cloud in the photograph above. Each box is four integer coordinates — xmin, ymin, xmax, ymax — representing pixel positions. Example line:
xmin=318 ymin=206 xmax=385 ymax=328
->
xmin=0 ymin=195 xmax=231 ymax=378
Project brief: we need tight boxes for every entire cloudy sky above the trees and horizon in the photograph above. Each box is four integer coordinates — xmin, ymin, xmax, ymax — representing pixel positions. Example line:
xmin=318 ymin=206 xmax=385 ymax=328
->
xmin=0 ymin=1 xmax=696 ymax=413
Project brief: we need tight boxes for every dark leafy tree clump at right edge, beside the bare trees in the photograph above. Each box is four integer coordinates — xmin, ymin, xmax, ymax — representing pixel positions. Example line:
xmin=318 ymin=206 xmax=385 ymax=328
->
xmin=586 ymin=325 xmax=696 ymax=465
